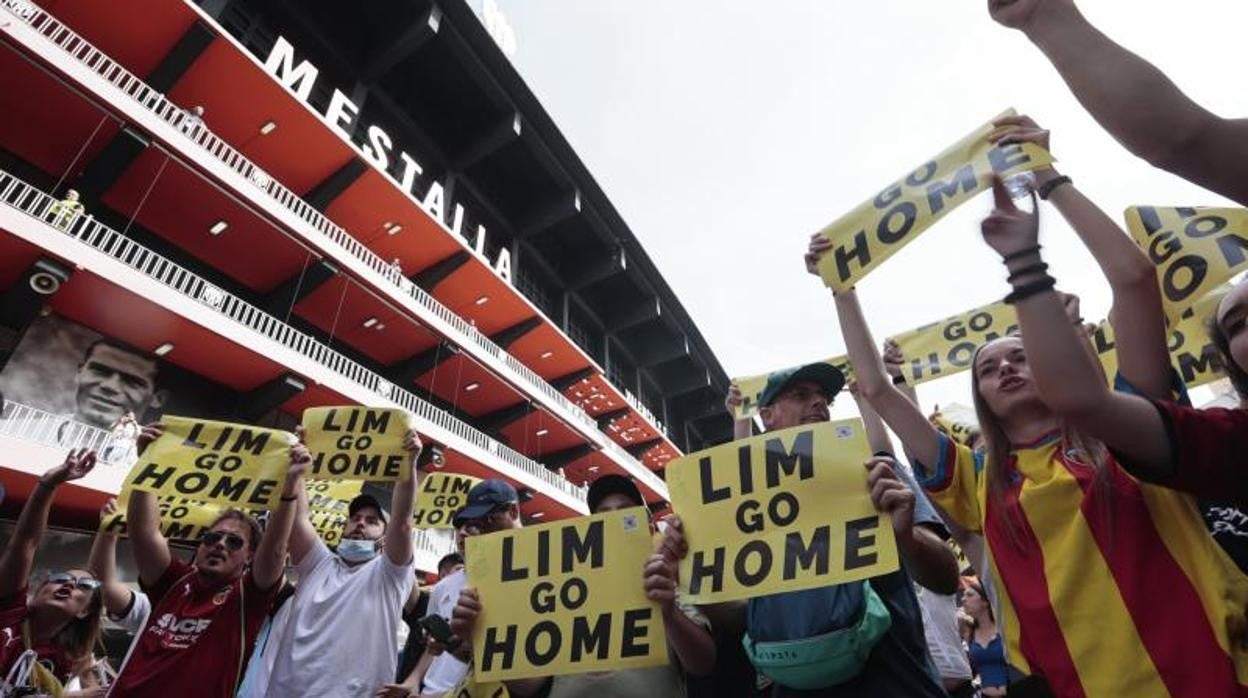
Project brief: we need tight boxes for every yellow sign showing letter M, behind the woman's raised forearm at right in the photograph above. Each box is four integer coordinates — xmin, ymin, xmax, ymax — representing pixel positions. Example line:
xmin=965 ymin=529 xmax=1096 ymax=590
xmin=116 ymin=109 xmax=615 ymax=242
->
xmin=1092 ymin=286 xmax=1231 ymax=388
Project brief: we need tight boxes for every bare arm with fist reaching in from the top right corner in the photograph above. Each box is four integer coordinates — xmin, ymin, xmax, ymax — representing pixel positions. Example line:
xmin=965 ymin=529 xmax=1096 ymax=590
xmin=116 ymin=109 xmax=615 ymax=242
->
xmin=988 ymin=0 xmax=1248 ymax=205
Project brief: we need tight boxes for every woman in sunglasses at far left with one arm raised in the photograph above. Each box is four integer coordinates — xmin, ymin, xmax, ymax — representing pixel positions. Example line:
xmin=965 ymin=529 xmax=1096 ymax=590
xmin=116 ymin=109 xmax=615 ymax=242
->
xmin=0 ymin=450 xmax=101 ymax=693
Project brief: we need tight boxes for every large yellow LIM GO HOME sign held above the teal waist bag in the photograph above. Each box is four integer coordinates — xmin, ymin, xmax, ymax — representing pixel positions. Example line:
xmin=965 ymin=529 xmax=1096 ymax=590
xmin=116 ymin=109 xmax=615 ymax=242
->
xmin=668 ymin=420 xmax=897 ymax=603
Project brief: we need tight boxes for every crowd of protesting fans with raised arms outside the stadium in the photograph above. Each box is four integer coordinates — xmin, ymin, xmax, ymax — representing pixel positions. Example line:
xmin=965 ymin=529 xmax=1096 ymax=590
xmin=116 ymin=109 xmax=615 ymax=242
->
xmin=0 ymin=0 xmax=1248 ymax=698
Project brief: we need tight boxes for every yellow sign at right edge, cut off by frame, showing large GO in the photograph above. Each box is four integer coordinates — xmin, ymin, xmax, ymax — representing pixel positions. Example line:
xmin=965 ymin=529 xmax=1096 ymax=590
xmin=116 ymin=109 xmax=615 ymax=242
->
xmin=1126 ymin=206 xmax=1248 ymax=321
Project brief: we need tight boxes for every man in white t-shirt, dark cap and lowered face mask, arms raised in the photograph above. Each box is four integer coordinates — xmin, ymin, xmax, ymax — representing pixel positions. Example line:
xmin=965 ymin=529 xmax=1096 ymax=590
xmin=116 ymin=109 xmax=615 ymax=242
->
xmin=263 ymin=431 xmax=421 ymax=698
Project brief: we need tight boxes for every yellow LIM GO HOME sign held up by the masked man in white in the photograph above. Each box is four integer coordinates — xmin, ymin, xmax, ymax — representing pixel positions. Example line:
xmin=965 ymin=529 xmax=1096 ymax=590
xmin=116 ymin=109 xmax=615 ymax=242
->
xmin=303 ymin=406 xmax=412 ymax=482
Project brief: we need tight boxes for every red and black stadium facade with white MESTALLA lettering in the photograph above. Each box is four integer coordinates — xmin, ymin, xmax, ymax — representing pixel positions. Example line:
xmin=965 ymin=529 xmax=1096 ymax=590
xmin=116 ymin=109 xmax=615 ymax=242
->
xmin=0 ymin=0 xmax=730 ymax=571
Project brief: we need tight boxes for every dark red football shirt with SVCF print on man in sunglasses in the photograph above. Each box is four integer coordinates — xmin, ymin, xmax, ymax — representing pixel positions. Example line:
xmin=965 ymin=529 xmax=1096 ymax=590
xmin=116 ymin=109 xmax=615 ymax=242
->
xmin=111 ymin=558 xmax=281 ymax=698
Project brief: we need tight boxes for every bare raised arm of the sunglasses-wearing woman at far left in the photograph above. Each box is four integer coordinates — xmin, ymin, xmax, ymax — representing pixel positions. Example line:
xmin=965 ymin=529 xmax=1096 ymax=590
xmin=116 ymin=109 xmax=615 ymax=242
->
xmin=0 ymin=448 xmax=95 ymax=598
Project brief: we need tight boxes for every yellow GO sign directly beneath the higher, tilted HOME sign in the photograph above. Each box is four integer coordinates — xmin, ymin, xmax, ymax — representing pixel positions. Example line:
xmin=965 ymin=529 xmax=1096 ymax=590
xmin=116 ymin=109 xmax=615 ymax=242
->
xmin=894 ymin=302 xmax=1018 ymax=386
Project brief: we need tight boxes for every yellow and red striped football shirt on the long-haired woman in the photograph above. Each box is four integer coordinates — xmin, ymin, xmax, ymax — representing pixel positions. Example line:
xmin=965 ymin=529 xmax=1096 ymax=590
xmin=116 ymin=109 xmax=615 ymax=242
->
xmin=920 ymin=435 xmax=1248 ymax=698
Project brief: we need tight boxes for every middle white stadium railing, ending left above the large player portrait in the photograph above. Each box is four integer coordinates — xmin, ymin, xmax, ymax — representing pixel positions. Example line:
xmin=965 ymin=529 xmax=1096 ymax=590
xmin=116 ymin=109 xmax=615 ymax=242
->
xmin=0 ymin=170 xmax=584 ymax=499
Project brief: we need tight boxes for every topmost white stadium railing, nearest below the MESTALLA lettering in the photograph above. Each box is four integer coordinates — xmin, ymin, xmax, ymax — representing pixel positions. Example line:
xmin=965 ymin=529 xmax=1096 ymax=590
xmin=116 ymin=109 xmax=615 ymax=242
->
xmin=4 ymin=0 xmax=666 ymax=496
